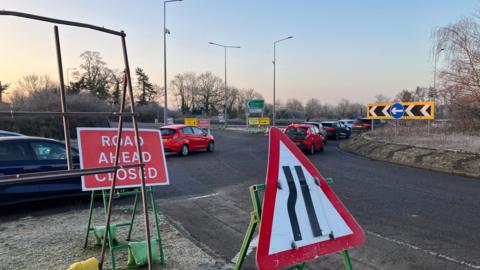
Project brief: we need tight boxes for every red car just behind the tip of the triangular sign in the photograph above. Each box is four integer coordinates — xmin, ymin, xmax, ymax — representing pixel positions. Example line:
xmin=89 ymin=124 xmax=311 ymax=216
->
xmin=284 ymin=124 xmax=325 ymax=155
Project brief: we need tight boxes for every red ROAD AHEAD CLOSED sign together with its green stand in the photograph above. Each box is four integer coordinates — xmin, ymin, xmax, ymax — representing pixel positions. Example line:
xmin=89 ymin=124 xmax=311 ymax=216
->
xmin=77 ymin=128 xmax=169 ymax=269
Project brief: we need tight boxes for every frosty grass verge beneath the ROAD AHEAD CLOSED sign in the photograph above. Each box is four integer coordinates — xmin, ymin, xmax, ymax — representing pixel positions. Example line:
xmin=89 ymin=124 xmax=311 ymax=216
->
xmin=0 ymin=207 xmax=225 ymax=269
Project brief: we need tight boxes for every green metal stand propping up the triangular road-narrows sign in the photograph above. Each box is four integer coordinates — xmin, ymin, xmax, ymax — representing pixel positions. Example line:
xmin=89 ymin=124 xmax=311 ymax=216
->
xmin=233 ymin=178 xmax=353 ymax=270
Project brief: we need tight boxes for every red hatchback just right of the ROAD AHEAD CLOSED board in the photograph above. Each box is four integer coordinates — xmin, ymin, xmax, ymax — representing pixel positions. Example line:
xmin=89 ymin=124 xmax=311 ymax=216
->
xmin=160 ymin=125 xmax=215 ymax=156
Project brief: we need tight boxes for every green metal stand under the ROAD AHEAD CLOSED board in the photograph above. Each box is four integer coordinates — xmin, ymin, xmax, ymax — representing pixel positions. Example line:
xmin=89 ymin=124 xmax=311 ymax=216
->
xmin=84 ymin=187 xmax=165 ymax=270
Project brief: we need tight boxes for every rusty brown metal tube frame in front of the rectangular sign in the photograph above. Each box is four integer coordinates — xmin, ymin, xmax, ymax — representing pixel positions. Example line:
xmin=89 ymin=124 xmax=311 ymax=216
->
xmin=0 ymin=10 xmax=153 ymax=270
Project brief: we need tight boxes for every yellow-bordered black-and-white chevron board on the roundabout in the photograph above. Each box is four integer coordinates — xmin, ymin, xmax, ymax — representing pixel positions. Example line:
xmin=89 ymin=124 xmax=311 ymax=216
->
xmin=367 ymin=101 xmax=435 ymax=120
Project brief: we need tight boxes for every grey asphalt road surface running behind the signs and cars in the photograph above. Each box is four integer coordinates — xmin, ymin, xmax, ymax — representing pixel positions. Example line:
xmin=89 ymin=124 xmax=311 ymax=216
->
xmin=1 ymin=131 xmax=480 ymax=270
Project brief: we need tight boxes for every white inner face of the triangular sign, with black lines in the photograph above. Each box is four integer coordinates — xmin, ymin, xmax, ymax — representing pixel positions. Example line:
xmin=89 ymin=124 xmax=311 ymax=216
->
xmin=269 ymin=141 xmax=353 ymax=255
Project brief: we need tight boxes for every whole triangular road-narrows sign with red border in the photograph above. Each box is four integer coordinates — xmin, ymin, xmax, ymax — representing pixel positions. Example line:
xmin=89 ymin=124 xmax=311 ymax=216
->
xmin=257 ymin=128 xmax=365 ymax=270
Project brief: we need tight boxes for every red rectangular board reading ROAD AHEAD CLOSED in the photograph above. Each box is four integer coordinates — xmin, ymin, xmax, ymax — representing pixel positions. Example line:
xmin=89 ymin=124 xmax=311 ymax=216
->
xmin=77 ymin=128 xmax=169 ymax=191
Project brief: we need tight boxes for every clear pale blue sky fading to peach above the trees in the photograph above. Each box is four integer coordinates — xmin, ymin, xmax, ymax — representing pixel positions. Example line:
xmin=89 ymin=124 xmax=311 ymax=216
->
xmin=0 ymin=0 xmax=480 ymax=104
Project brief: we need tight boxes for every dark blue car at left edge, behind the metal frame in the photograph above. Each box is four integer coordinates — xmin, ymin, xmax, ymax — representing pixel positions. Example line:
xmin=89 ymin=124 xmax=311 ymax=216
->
xmin=0 ymin=136 xmax=82 ymax=205
